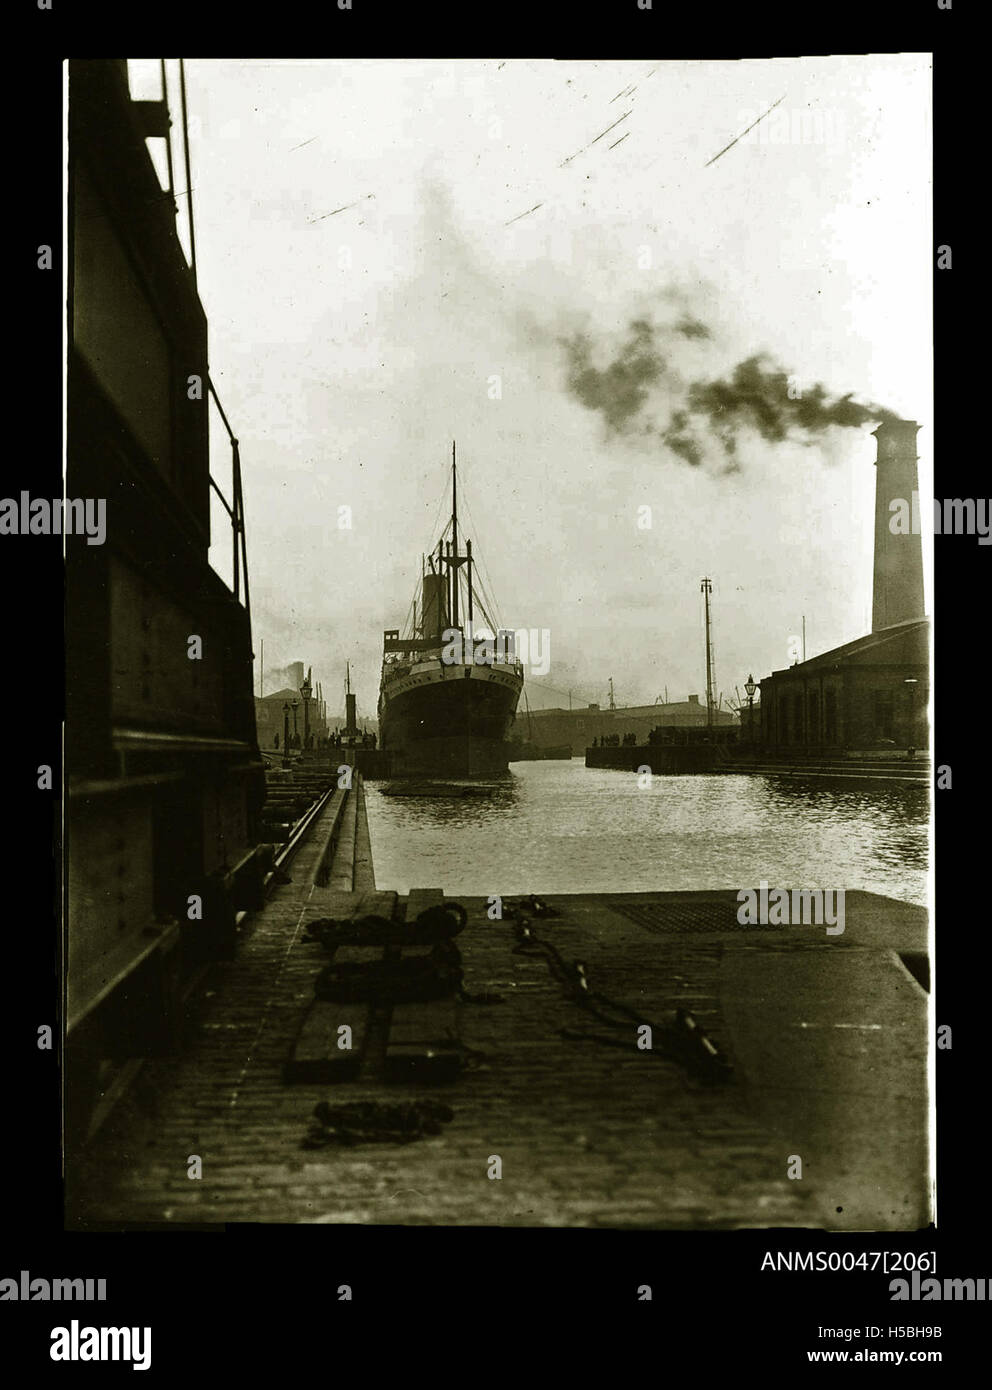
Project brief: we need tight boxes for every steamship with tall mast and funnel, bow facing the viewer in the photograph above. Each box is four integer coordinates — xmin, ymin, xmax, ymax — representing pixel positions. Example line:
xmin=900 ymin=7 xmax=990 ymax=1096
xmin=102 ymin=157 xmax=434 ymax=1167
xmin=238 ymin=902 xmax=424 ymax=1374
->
xmin=378 ymin=445 xmax=524 ymax=777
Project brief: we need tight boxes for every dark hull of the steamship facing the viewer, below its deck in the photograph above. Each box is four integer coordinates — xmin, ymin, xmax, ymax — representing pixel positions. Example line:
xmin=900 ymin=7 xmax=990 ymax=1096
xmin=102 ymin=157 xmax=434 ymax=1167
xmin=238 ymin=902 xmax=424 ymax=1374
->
xmin=379 ymin=662 xmax=522 ymax=777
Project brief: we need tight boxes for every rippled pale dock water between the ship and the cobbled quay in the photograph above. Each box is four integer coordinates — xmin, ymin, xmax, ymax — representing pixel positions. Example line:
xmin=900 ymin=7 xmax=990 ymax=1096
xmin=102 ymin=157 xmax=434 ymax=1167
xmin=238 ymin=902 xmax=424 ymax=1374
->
xmin=365 ymin=758 xmax=929 ymax=904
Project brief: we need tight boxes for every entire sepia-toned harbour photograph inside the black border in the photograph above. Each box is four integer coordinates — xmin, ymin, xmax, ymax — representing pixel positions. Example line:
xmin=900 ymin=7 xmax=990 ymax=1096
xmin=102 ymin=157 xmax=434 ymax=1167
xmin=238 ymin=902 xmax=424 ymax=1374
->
xmin=58 ymin=51 xmax=939 ymax=1239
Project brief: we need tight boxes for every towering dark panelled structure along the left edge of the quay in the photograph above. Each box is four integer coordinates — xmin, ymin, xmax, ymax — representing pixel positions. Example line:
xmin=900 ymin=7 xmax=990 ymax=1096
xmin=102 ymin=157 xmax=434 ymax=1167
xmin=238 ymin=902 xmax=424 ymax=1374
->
xmin=64 ymin=60 xmax=265 ymax=1141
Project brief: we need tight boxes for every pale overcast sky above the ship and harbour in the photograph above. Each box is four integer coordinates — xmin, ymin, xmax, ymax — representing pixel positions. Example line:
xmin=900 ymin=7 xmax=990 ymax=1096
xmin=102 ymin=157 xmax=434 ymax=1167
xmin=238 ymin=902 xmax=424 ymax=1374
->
xmin=132 ymin=54 xmax=932 ymax=713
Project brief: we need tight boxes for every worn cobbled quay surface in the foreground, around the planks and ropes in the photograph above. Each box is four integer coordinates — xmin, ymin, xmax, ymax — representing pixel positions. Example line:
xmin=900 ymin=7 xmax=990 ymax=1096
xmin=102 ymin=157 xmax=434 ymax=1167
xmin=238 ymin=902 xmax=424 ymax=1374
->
xmin=67 ymin=885 xmax=927 ymax=1229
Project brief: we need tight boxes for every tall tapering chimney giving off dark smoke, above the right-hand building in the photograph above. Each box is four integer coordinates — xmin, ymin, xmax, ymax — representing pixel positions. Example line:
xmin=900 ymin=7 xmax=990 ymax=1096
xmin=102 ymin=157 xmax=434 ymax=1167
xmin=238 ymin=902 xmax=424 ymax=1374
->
xmin=871 ymin=420 xmax=924 ymax=632
